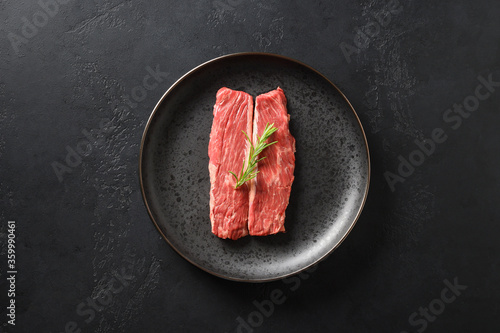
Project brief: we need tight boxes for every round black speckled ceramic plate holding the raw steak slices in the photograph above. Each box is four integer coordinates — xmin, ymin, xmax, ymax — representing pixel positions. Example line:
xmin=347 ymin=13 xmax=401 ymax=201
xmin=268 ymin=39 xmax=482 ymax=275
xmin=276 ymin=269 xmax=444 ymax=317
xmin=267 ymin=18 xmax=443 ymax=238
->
xmin=139 ymin=53 xmax=370 ymax=282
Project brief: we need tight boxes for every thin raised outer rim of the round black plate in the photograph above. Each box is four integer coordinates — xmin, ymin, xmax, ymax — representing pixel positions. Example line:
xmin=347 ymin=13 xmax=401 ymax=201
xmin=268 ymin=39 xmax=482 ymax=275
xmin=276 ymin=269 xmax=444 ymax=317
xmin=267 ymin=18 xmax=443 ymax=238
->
xmin=138 ymin=52 xmax=371 ymax=283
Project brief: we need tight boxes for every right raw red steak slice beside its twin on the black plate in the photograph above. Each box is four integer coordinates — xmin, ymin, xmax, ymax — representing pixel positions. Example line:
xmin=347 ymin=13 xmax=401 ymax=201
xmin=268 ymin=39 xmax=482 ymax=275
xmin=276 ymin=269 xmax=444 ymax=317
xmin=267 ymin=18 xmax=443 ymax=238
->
xmin=248 ymin=88 xmax=295 ymax=236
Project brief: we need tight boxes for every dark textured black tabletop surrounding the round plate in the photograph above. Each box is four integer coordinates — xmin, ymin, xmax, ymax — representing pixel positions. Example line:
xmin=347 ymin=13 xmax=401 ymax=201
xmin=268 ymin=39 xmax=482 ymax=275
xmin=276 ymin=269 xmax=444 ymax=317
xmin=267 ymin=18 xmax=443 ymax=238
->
xmin=0 ymin=0 xmax=500 ymax=333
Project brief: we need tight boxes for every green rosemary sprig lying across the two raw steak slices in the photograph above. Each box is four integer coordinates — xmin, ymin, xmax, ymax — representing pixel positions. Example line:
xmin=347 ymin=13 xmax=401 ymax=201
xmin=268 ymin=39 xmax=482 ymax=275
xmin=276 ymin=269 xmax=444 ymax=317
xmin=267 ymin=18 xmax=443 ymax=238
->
xmin=229 ymin=123 xmax=278 ymax=189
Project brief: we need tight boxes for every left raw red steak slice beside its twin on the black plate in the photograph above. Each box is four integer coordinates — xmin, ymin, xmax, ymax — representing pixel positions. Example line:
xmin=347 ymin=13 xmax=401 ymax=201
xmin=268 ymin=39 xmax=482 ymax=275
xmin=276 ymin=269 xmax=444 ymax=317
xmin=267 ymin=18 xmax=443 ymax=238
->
xmin=208 ymin=88 xmax=253 ymax=239
